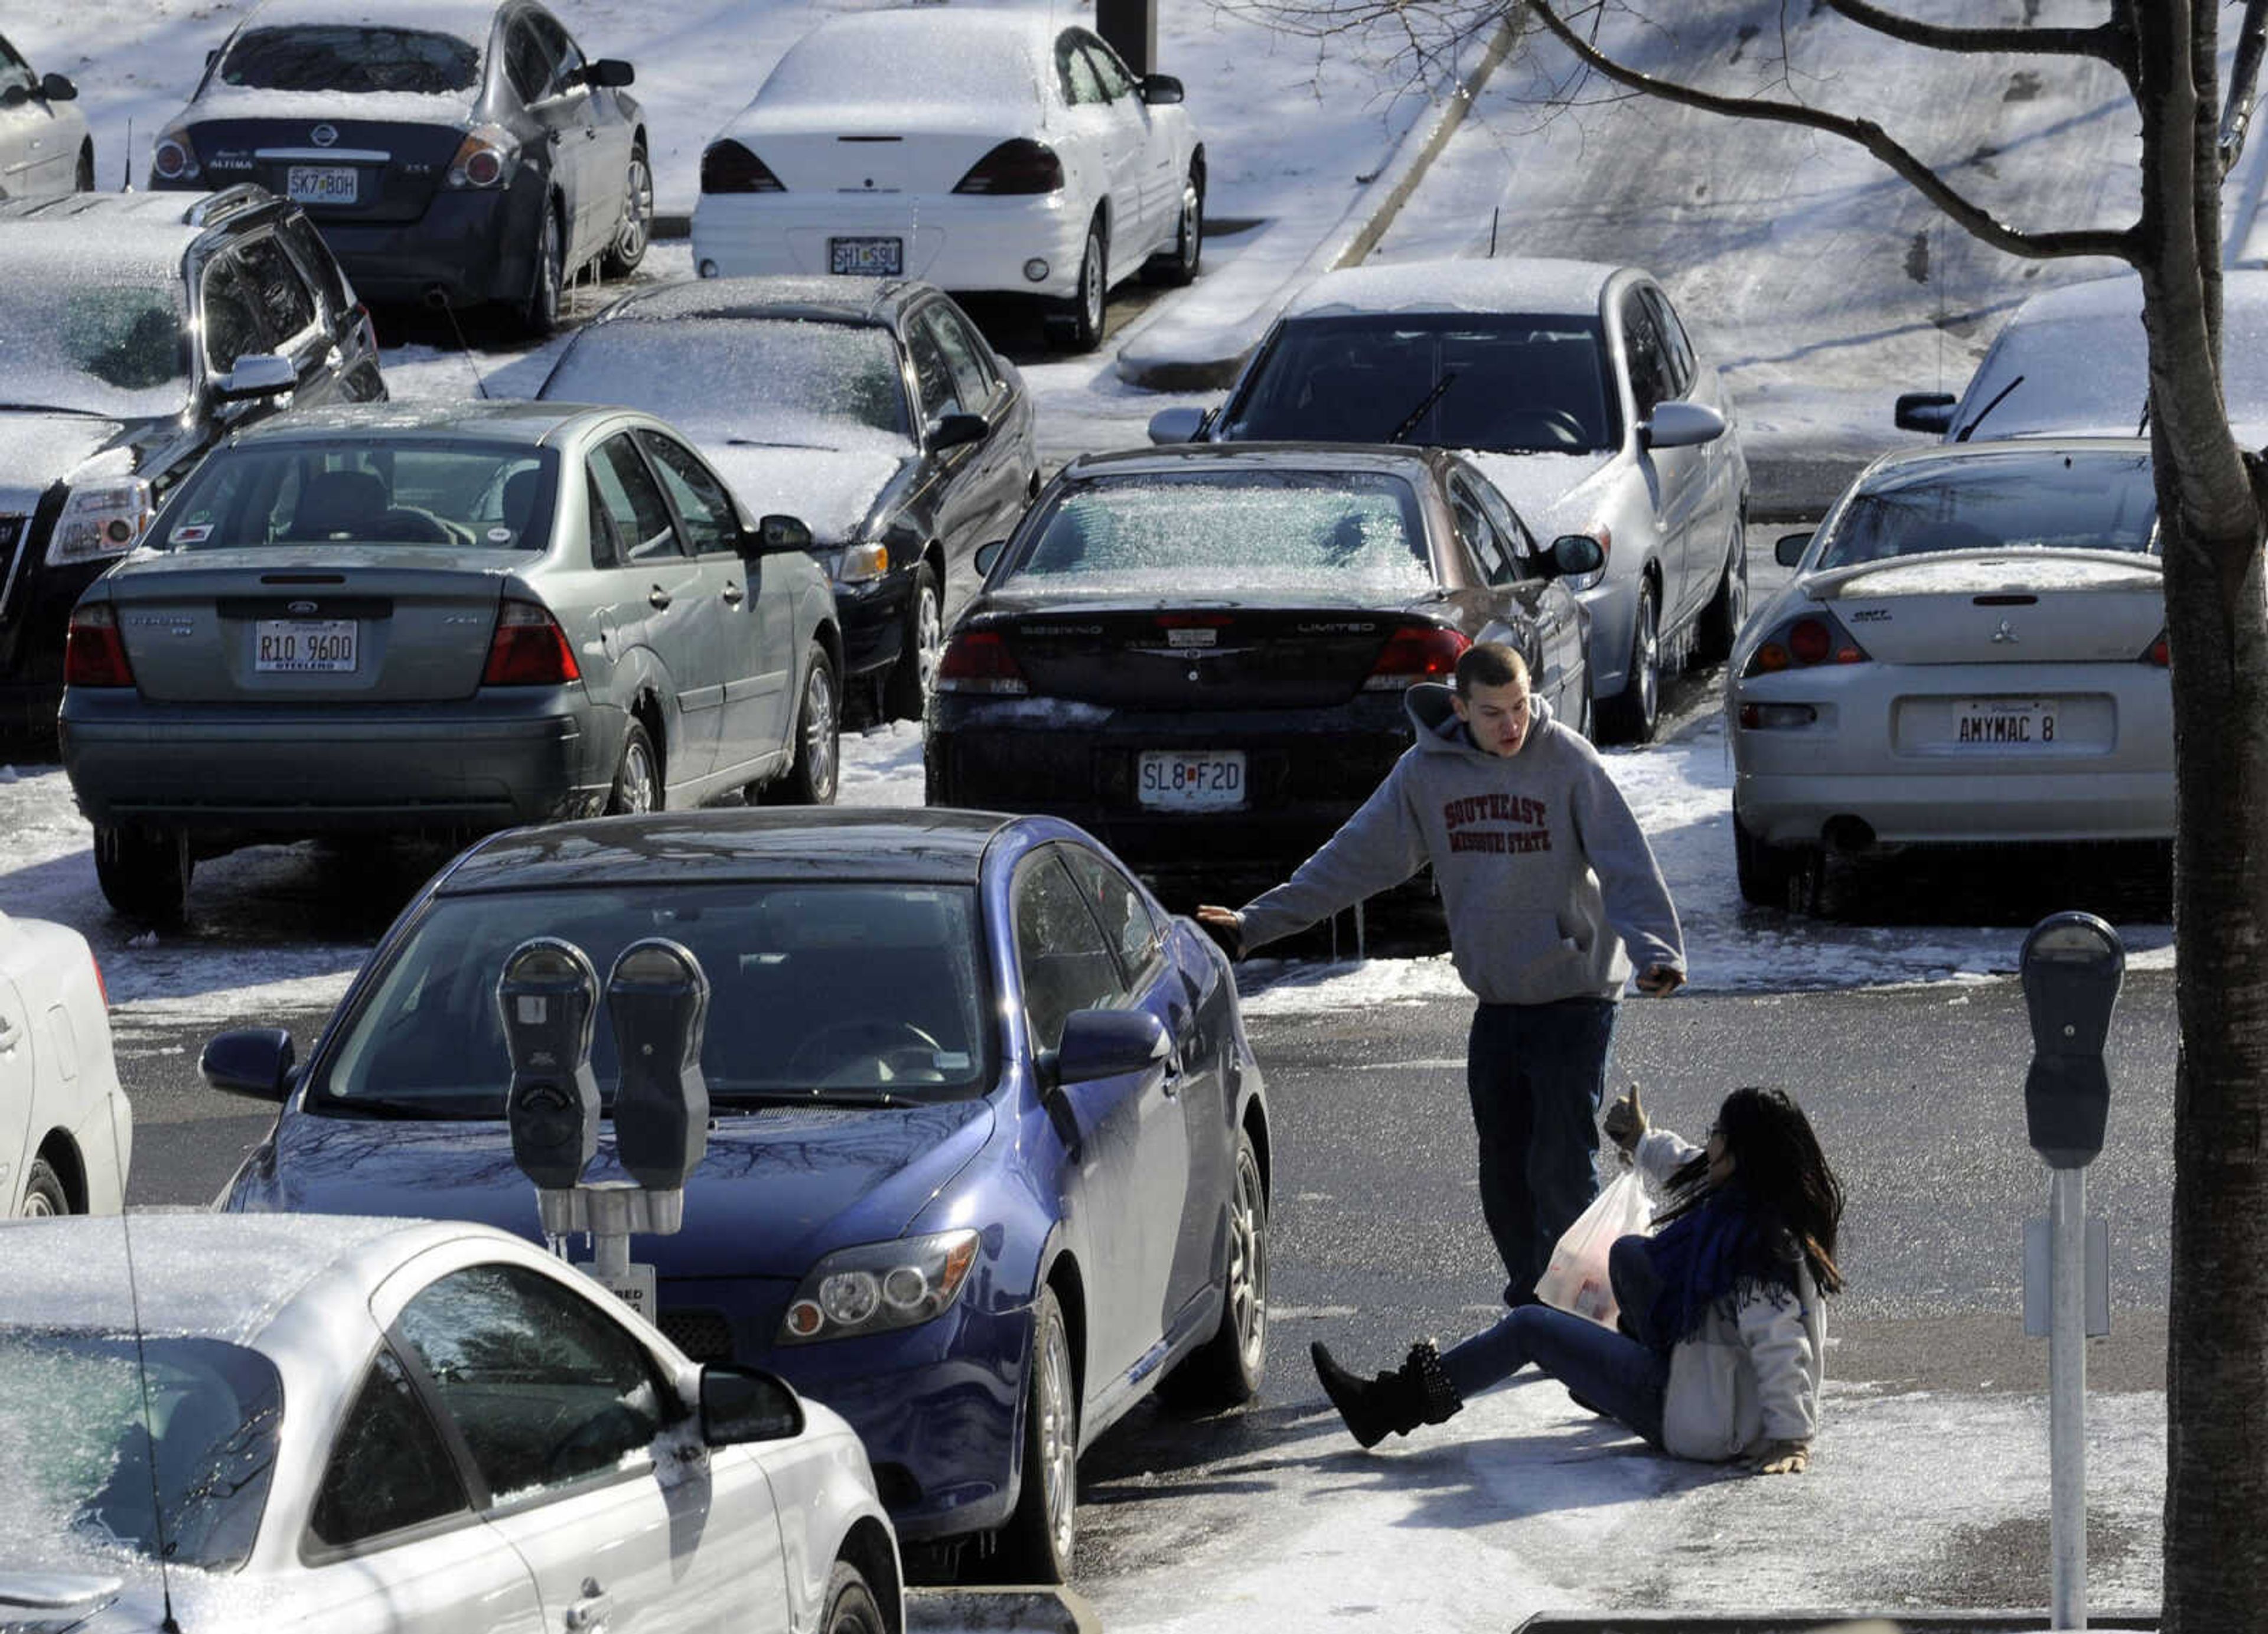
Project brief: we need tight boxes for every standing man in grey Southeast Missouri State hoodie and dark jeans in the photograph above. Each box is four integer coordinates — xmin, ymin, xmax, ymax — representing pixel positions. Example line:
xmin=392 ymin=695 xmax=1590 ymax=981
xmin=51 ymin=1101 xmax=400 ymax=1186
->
xmin=1198 ymin=641 xmax=1685 ymax=1306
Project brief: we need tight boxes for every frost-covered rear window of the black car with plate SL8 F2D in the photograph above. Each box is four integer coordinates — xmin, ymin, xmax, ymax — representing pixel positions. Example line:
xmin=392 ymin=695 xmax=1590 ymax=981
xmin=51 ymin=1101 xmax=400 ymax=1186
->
xmin=1000 ymin=469 xmax=1433 ymax=596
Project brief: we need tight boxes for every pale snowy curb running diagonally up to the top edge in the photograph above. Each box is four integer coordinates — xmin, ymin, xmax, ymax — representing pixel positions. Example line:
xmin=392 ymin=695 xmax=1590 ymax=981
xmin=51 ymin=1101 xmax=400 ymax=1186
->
xmin=1118 ymin=7 xmax=1524 ymax=392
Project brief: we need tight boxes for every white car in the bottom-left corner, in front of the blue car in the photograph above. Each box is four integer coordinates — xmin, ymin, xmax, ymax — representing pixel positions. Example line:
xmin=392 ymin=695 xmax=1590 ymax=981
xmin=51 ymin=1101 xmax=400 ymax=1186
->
xmin=0 ymin=1215 xmax=902 ymax=1634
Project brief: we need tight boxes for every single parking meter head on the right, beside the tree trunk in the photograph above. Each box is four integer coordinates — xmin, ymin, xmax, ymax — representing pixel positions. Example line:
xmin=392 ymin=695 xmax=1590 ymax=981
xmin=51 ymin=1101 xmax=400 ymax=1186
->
xmin=2021 ymin=914 xmax=2125 ymax=1169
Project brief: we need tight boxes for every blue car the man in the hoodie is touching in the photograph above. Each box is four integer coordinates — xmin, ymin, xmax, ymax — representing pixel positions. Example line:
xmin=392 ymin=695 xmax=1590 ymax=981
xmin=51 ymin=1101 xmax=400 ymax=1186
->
xmin=204 ymin=811 xmax=1270 ymax=1582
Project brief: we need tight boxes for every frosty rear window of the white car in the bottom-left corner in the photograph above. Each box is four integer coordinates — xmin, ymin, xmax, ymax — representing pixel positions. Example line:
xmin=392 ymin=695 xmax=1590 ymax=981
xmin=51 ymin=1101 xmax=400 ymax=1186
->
xmin=0 ymin=1328 xmax=284 ymax=1571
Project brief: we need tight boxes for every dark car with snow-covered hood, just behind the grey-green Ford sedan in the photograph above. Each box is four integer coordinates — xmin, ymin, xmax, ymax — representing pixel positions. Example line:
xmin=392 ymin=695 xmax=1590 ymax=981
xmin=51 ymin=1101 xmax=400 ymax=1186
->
xmin=535 ymin=279 xmax=1039 ymax=720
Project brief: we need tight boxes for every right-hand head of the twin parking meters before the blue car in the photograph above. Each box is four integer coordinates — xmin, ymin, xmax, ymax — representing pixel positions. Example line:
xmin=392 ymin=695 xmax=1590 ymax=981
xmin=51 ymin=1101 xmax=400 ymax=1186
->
xmin=605 ymin=936 xmax=708 ymax=1192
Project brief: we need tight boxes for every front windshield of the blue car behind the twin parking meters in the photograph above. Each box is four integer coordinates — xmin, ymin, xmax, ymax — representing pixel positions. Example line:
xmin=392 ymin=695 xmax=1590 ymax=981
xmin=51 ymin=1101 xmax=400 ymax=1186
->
xmin=311 ymin=884 xmax=991 ymax=1117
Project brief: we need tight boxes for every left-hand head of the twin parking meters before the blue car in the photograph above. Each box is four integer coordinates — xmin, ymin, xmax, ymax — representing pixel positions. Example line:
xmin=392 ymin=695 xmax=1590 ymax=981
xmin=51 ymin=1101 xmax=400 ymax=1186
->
xmin=497 ymin=936 xmax=599 ymax=1190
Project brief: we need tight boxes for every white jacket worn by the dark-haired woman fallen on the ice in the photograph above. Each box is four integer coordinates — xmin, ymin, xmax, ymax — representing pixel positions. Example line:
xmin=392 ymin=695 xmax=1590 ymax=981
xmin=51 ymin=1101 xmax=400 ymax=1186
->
xmin=1633 ymin=1129 xmax=1826 ymax=1464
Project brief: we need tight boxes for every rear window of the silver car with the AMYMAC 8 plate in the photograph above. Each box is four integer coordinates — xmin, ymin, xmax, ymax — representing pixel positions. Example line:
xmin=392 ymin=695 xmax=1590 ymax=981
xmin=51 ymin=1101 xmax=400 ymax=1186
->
xmin=1812 ymin=454 xmax=2157 ymax=569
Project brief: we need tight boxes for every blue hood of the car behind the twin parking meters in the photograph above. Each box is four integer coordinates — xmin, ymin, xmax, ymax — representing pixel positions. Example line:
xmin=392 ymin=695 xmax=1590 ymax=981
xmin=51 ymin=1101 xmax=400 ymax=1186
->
xmin=239 ymin=1099 xmax=993 ymax=1278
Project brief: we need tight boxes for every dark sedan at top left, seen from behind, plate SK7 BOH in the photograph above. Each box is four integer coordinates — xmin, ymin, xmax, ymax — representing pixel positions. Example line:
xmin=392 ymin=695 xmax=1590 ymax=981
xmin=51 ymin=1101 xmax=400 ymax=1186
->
xmin=149 ymin=0 xmax=653 ymax=335
